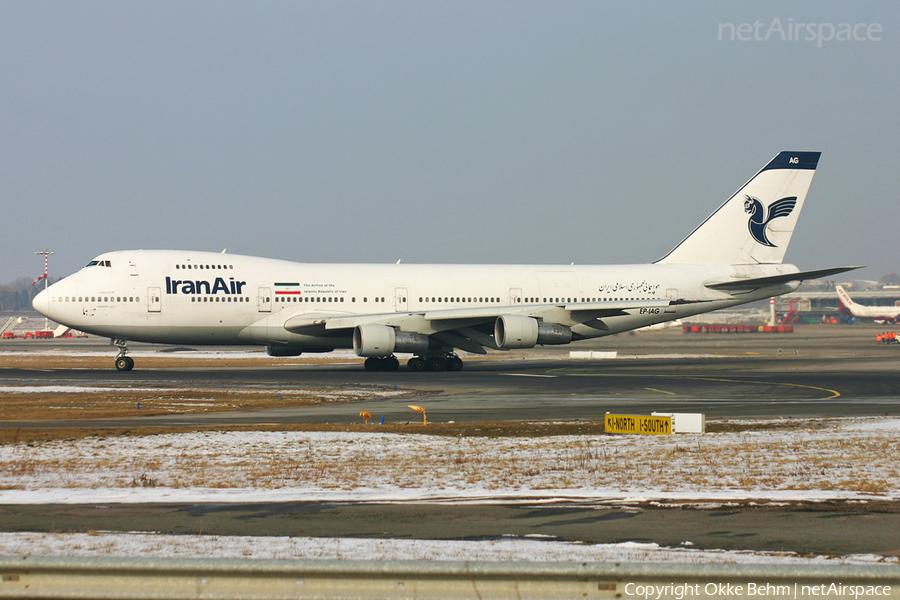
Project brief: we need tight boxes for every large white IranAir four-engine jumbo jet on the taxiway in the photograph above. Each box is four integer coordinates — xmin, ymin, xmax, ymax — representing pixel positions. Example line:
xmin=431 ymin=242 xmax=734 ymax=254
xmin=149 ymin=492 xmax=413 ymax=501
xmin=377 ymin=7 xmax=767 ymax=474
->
xmin=33 ymin=152 xmax=859 ymax=371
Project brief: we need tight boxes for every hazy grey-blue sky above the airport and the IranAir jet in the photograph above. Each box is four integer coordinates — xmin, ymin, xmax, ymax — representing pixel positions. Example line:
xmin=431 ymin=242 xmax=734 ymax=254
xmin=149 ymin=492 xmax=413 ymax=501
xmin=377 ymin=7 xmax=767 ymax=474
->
xmin=0 ymin=0 xmax=900 ymax=283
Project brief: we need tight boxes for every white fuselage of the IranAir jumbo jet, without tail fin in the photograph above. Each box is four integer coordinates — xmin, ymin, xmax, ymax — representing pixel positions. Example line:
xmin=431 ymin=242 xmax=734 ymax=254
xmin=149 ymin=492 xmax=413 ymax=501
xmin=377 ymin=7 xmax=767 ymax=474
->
xmin=34 ymin=250 xmax=798 ymax=351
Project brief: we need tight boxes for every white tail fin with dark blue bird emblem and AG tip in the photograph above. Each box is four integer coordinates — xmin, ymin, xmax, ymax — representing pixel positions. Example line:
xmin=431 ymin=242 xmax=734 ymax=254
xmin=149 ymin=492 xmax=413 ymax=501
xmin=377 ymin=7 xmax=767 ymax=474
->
xmin=656 ymin=152 xmax=822 ymax=265
